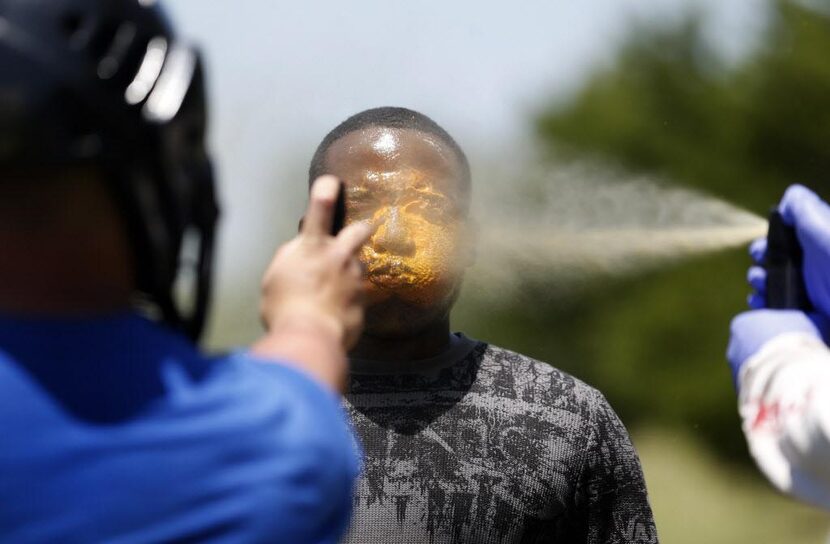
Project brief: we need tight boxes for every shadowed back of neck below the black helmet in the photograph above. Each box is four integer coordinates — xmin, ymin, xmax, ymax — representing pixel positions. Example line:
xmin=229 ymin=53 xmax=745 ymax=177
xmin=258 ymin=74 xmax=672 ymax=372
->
xmin=0 ymin=169 xmax=135 ymax=317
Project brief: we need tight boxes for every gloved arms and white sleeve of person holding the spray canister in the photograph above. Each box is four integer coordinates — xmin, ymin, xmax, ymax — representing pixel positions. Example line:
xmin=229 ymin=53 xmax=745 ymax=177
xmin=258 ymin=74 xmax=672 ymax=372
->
xmin=727 ymin=185 xmax=830 ymax=509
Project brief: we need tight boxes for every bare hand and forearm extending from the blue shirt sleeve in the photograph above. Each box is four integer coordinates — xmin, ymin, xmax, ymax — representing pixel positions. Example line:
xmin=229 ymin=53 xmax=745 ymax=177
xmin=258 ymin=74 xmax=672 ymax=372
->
xmin=252 ymin=176 xmax=371 ymax=391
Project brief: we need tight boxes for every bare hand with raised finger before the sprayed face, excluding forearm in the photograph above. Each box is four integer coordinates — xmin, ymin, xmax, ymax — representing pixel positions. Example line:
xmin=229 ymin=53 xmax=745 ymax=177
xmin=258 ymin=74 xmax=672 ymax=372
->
xmin=260 ymin=176 xmax=370 ymax=350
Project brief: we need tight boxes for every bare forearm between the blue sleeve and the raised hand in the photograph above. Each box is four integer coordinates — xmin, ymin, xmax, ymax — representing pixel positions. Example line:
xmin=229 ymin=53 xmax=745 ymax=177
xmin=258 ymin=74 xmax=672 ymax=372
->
xmin=251 ymin=318 xmax=348 ymax=393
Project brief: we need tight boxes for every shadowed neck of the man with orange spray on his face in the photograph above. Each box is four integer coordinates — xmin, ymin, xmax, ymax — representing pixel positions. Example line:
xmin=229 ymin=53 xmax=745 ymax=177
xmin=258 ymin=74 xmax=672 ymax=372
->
xmin=349 ymin=319 xmax=450 ymax=362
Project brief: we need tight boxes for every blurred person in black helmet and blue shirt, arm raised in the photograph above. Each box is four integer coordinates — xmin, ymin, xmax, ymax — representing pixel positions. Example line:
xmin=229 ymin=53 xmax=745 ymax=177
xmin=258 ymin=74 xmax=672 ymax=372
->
xmin=0 ymin=0 xmax=369 ymax=544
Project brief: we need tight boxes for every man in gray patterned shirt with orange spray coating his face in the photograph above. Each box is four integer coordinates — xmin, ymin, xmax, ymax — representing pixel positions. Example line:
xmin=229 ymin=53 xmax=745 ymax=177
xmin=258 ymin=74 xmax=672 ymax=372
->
xmin=310 ymin=108 xmax=657 ymax=544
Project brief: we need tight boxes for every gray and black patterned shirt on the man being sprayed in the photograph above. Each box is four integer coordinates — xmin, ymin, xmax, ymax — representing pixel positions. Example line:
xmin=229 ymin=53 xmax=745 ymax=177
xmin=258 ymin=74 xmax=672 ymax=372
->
xmin=346 ymin=335 xmax=657 ymax=544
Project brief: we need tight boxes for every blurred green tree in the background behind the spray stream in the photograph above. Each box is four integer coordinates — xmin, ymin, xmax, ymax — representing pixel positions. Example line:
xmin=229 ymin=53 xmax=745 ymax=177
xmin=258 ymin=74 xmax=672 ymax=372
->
xmin=470 ymin=0 xmax=830 ymax=461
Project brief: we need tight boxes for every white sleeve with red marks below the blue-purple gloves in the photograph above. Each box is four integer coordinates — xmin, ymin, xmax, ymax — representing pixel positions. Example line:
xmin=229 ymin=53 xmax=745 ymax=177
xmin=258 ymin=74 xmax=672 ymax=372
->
xmin=738 ymin=333 xmax=830 ymax=509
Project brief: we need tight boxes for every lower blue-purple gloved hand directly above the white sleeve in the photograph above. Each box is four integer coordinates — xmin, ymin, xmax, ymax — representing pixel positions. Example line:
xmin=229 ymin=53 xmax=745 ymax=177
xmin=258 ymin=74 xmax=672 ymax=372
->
xmin=726 ymin=310 xmax=830 ymax=389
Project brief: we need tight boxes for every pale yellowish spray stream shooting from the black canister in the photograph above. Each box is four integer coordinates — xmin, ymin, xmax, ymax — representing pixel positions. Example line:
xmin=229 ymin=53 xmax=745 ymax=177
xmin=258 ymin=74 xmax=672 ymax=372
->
xmin=462 ymin=159 xmax=767 ymax=296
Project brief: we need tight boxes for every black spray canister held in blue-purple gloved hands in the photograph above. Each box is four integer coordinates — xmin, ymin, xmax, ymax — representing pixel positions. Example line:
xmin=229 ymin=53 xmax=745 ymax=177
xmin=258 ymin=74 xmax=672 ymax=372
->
xmin=764 ymin=210 xmax=813 ymax=312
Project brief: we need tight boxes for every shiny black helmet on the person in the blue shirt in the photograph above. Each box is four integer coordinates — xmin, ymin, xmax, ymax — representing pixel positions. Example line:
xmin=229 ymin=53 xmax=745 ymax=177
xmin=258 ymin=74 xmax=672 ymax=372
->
xmin=0 ymin=0 xmax=218 ymax=339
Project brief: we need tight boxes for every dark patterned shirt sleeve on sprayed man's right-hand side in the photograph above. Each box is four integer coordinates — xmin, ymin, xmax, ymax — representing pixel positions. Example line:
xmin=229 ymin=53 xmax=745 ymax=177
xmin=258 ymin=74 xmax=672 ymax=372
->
xmin=579 ymin=393 xmax=657 ymax=544
